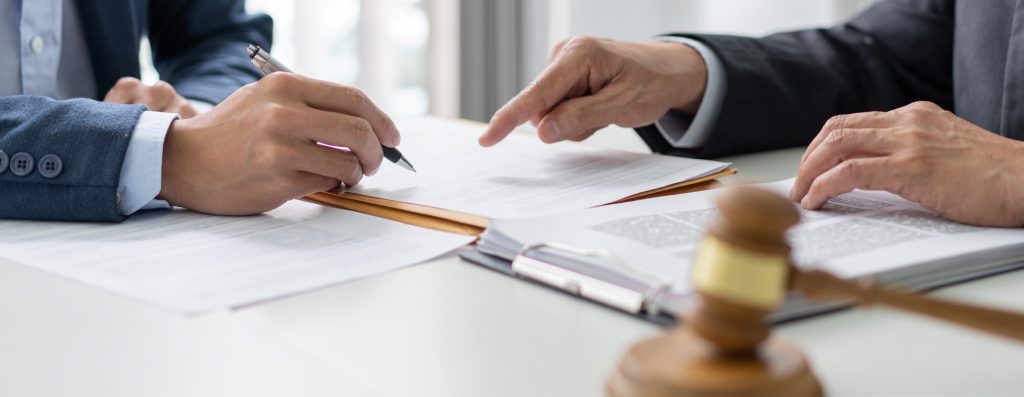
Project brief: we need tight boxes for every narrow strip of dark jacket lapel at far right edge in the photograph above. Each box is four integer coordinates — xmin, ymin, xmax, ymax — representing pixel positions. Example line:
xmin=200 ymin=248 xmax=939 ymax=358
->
xmin=998 ymin=0 xmax=1024 ymax=139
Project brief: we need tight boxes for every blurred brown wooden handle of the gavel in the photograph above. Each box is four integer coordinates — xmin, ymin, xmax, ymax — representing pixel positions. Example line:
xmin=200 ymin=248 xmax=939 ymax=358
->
xmin=793 ymin=267 xmax=1024 ymax=343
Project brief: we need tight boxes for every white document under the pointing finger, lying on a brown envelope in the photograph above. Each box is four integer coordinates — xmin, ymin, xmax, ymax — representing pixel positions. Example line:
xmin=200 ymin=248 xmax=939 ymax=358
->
xmin=349 ymin=119 xmax=728 ymax=219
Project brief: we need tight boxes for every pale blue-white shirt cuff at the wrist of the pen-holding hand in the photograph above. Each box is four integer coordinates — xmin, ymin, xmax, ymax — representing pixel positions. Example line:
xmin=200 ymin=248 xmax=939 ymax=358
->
xmin=118 ymin=112 xmax=178 ymax=216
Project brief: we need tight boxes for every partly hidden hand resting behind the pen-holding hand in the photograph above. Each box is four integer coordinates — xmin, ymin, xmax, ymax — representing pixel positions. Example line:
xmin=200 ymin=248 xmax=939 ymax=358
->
xmin=103 ymin=77 xmax=199 ymax=119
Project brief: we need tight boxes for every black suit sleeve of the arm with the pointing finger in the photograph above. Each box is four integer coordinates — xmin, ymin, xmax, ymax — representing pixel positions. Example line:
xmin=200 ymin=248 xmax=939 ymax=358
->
xmin=638 ymin=0 xmax=954 ymax=158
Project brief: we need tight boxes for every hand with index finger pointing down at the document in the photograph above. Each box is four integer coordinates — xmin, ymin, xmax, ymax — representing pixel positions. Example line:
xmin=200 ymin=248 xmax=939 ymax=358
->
xmin=480 ymin=37 xmax=708 ymax=146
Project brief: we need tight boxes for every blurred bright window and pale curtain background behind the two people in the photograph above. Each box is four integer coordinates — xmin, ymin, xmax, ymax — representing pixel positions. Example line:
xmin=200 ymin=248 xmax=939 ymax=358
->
xmin=143 ymin=0 xmax=872 ymax=121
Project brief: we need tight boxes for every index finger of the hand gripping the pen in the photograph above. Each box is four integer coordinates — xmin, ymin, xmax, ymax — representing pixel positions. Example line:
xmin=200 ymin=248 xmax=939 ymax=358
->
xmin=286 ymin=75 xmax=401 ymax=147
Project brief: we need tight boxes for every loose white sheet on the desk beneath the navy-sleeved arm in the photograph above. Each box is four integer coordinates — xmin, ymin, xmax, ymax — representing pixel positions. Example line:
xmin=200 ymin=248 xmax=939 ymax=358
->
xmin=0 ymin=202 xmax=472 ymax=313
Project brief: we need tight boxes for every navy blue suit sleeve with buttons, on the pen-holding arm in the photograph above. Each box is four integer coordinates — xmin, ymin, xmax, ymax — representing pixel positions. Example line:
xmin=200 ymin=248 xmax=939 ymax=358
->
xmin=0 ymin=96 xmax=145 ymax=221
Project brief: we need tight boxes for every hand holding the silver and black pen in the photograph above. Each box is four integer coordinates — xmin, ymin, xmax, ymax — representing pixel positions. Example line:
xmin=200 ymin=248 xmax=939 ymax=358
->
xmin=159 ymin=73 xmax=399 ymax=215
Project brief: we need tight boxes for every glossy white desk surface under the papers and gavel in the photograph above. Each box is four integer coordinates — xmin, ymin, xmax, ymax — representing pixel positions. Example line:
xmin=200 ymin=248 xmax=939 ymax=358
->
xmin=0 ymin=130 xmax=1024 ymax=397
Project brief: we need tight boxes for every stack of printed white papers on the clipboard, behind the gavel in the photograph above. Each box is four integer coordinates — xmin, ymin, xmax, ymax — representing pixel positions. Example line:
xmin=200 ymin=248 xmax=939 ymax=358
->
xmin=479 ymin=180 xmax=1024 ymax=292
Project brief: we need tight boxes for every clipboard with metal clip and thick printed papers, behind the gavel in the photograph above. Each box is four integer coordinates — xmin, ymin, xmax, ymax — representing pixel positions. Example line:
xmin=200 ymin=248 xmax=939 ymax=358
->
xmin=463 ymin=180 xmax=1024 ymax=320
